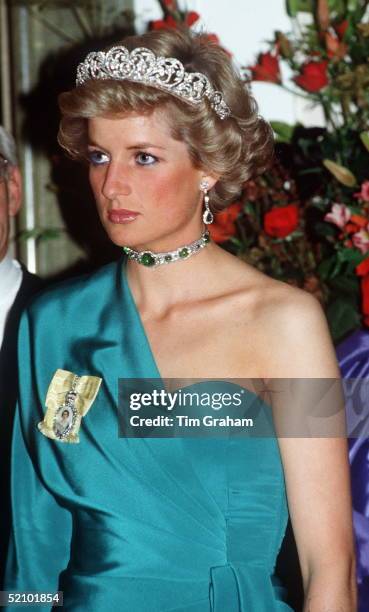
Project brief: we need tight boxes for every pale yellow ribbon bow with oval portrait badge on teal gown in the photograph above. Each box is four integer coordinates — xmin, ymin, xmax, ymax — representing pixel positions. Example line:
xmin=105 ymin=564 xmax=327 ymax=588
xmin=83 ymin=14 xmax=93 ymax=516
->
xmin=37 ymin=369 xmax=102 ymax=444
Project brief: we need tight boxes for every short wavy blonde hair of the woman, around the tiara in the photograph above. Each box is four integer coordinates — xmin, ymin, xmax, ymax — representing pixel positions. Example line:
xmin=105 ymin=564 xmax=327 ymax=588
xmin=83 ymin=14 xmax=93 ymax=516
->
xmin=58 ymin=28 xmax=274 ymax=211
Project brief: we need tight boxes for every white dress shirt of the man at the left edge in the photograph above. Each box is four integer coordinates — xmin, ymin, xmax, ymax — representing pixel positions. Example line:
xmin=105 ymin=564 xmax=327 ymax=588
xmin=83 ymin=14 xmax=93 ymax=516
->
xmin=0 ymin=252 xmax=23 ymax=348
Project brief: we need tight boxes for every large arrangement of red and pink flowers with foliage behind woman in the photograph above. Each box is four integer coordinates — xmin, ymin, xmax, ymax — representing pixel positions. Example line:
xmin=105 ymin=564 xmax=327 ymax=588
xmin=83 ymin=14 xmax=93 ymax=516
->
xmin=151 ymin=0 xmax=369 ymax=341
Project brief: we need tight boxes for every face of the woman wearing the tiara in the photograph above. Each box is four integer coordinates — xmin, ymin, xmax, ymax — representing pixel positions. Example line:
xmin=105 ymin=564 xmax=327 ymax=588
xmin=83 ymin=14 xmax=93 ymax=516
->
xmin=88 ymin=111 xmax=215 ymax=251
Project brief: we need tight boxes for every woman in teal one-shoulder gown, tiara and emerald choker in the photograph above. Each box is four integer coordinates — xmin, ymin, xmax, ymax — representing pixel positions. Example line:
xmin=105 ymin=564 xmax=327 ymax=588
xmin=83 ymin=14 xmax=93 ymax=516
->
xmin=6 ymin=30 xmax=355 ymax=612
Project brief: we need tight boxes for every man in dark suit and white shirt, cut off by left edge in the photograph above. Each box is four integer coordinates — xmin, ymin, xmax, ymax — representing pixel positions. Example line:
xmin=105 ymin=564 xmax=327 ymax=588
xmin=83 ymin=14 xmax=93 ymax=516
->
xmin=0 ymin=126 xmax=43 ymax=590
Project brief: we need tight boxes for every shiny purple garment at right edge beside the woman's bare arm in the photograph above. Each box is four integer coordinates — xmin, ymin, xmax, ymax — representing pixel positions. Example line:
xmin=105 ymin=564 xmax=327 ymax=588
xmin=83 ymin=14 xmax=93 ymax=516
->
xmin=336 ymin=330 xmax=369 ymax=612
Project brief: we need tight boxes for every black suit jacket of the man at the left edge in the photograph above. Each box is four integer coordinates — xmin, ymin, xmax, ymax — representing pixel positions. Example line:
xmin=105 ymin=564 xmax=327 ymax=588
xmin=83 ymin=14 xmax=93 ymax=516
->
xmin=0 ymin=265 xmax=45 ymax=590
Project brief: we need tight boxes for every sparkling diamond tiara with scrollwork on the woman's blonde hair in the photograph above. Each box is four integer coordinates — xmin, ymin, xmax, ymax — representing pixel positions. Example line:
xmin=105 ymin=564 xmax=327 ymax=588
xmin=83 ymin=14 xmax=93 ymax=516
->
xmin=76 ymin=46 xmax=231 ymax=119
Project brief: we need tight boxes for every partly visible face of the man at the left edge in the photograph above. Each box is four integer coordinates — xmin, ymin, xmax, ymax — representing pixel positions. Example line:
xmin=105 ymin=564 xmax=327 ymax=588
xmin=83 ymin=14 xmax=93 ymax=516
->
xmin=0 ymin=167 xmax=22 ymax=261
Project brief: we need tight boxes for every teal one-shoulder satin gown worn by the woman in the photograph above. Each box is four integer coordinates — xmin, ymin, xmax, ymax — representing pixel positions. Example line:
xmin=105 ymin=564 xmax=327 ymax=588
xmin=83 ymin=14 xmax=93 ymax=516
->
xmin=4 ymin=257 xmax=291 ymax=612
